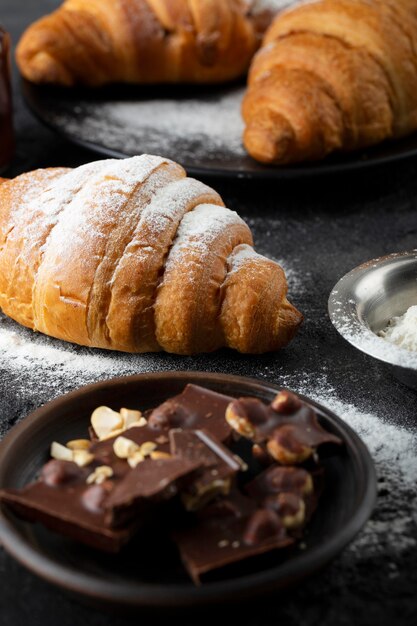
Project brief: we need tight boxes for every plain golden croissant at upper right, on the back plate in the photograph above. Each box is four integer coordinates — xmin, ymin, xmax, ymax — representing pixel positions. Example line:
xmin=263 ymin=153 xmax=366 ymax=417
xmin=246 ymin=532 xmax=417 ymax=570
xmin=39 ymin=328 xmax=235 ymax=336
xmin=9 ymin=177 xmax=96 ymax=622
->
xmin=242 ymin=0 xmax=417 ymax=164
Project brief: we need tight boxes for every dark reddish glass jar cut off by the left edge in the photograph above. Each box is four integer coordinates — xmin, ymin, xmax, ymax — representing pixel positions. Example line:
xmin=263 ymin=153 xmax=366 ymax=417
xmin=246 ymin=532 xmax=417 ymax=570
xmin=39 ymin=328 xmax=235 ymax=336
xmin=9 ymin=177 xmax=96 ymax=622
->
xmin=0 ymin=26 xmax=14 ymax=173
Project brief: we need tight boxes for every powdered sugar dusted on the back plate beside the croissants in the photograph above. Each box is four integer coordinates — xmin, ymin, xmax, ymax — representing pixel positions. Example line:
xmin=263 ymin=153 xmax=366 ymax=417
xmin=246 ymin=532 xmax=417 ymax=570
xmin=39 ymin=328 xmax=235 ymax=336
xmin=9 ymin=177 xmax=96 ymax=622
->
xmin=45 ymin=86 xmax=246 ymax=163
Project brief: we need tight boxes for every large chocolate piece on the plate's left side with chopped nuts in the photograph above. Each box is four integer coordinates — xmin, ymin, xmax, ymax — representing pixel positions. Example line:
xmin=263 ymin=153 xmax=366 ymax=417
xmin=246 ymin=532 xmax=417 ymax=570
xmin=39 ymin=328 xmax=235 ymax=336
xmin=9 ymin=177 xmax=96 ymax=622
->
xmin=0 ymin=448 xmax=199 ymax=552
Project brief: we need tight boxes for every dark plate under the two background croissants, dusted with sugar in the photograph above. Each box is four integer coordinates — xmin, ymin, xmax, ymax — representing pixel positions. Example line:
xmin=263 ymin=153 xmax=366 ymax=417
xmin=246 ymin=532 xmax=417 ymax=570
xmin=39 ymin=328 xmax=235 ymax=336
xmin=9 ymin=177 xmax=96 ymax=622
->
xmin=23 ymin=81 xmax=417 ymax=179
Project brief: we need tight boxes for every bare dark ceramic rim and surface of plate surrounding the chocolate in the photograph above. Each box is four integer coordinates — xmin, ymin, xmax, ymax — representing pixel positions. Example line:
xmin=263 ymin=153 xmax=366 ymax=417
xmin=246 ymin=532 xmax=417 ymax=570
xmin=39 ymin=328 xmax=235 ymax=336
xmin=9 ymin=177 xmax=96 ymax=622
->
xmin=0 ymin=372 xmax=376 ymax=607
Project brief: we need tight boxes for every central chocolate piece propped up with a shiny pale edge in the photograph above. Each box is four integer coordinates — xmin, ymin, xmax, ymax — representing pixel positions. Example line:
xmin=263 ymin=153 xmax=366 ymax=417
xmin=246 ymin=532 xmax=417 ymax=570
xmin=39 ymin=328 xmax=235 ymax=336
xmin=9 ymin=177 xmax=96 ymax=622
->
xmin=169 ymin=429 xmax=247 ymax=511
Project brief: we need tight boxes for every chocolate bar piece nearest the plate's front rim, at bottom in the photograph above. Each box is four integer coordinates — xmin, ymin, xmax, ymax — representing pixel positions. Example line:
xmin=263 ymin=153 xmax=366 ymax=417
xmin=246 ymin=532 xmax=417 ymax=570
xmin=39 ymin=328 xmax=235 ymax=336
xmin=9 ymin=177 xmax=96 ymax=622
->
xmin=174 ymin=493 xmax=295 ymax=585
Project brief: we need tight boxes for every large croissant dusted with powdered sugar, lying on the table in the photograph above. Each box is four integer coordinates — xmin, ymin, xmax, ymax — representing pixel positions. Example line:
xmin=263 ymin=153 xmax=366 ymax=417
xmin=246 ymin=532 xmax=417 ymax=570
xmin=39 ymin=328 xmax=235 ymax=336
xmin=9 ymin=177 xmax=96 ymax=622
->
xmin=0 ymin=155 xmax=302 ymax=354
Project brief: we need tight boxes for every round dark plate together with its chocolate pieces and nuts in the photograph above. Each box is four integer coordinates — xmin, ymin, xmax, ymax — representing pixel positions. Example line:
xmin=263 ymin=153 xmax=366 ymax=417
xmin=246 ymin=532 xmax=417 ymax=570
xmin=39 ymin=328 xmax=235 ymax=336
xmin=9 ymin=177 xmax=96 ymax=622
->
xmin=0 ymin=372 xmax=376 ymax=608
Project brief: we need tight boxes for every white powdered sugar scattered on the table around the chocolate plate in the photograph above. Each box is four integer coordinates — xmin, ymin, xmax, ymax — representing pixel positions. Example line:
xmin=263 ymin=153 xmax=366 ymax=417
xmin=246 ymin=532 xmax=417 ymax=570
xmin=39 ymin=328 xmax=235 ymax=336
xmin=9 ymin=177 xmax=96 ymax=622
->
xmin=0 ymin=316 xmax=417 ymax=566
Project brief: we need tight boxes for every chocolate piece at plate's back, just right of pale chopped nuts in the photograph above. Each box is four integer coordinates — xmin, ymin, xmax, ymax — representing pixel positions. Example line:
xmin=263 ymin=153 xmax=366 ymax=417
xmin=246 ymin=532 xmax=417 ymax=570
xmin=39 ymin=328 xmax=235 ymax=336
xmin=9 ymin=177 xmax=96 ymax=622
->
xmin=148 ymin=385 xmax=233 ymax=442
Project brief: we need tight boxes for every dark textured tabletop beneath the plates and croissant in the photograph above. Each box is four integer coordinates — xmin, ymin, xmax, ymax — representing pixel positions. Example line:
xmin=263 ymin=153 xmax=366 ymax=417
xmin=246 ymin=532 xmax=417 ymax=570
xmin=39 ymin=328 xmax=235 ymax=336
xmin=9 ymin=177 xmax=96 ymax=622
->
xmin=0 ymin=0 xmax=417 ymax=626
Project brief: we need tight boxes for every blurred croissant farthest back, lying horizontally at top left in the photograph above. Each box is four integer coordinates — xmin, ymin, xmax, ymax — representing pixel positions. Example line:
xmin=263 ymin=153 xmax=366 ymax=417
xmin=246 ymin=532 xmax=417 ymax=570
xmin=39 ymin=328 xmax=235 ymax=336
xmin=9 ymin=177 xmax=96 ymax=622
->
xmin=17 ymin=0 xmax=277 ymax=86
